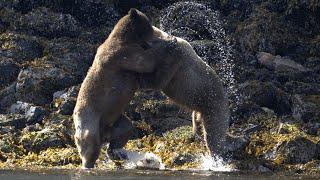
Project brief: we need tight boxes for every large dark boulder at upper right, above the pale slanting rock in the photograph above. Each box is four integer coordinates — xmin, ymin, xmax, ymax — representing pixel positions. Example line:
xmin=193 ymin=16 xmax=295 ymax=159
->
xmin=235 ymin=6 xmax=298 ymax=54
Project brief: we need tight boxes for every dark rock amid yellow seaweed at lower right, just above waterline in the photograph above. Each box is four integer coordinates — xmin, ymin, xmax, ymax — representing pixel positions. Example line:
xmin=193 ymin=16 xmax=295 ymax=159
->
xmin=277 ymin=137 xmax=318 ymax=164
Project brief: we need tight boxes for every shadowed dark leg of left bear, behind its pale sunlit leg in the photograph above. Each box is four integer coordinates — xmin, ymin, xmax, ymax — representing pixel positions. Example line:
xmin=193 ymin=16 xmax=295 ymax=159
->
xmin=107 ymin=115 xmax=133 ymax=160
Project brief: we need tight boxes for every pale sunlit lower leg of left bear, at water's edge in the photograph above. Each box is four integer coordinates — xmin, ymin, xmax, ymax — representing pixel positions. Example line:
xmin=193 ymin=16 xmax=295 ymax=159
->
xmin=73 ymin=113 xmax=101 ymax=168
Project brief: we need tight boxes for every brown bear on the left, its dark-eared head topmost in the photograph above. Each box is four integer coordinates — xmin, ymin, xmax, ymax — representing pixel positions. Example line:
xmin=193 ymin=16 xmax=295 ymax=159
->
xmin=73 ymin=9 xmax=176 ymax=168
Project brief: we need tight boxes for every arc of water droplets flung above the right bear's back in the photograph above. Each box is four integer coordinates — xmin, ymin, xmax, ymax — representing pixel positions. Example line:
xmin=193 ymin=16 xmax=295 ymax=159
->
xmin=160 ymin=2 xmax=240 ymax=121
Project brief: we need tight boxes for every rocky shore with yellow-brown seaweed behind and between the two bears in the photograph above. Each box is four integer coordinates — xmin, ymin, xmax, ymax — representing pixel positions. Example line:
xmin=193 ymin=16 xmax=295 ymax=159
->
xmin=0 ymin=0 xmax=320 ymax=174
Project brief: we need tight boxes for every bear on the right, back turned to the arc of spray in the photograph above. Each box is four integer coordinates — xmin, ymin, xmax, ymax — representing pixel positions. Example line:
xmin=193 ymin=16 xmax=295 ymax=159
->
xmin=140 ymin=27 xmax=229 ymax=158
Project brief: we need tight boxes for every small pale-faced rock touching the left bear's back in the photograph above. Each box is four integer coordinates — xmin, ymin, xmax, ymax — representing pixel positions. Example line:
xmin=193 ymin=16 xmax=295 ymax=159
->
xmin=53 ymin=86 xmax=80 ymax=115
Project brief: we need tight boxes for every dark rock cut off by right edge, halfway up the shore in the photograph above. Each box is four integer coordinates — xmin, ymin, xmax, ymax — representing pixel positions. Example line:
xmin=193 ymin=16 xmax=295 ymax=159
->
xmin=292 ymin=94 xmax=320 ymax=122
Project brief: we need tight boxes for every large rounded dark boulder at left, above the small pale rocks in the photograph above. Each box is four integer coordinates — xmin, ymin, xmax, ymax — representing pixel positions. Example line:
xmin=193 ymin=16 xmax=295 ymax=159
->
xmin=16 ymin=66 xmax=74 ymax=105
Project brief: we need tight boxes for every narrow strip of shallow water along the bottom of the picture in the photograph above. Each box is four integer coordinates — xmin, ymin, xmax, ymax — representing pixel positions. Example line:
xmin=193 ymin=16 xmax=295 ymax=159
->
xmin=0 ymin=169 xmax=319 ymax=180
